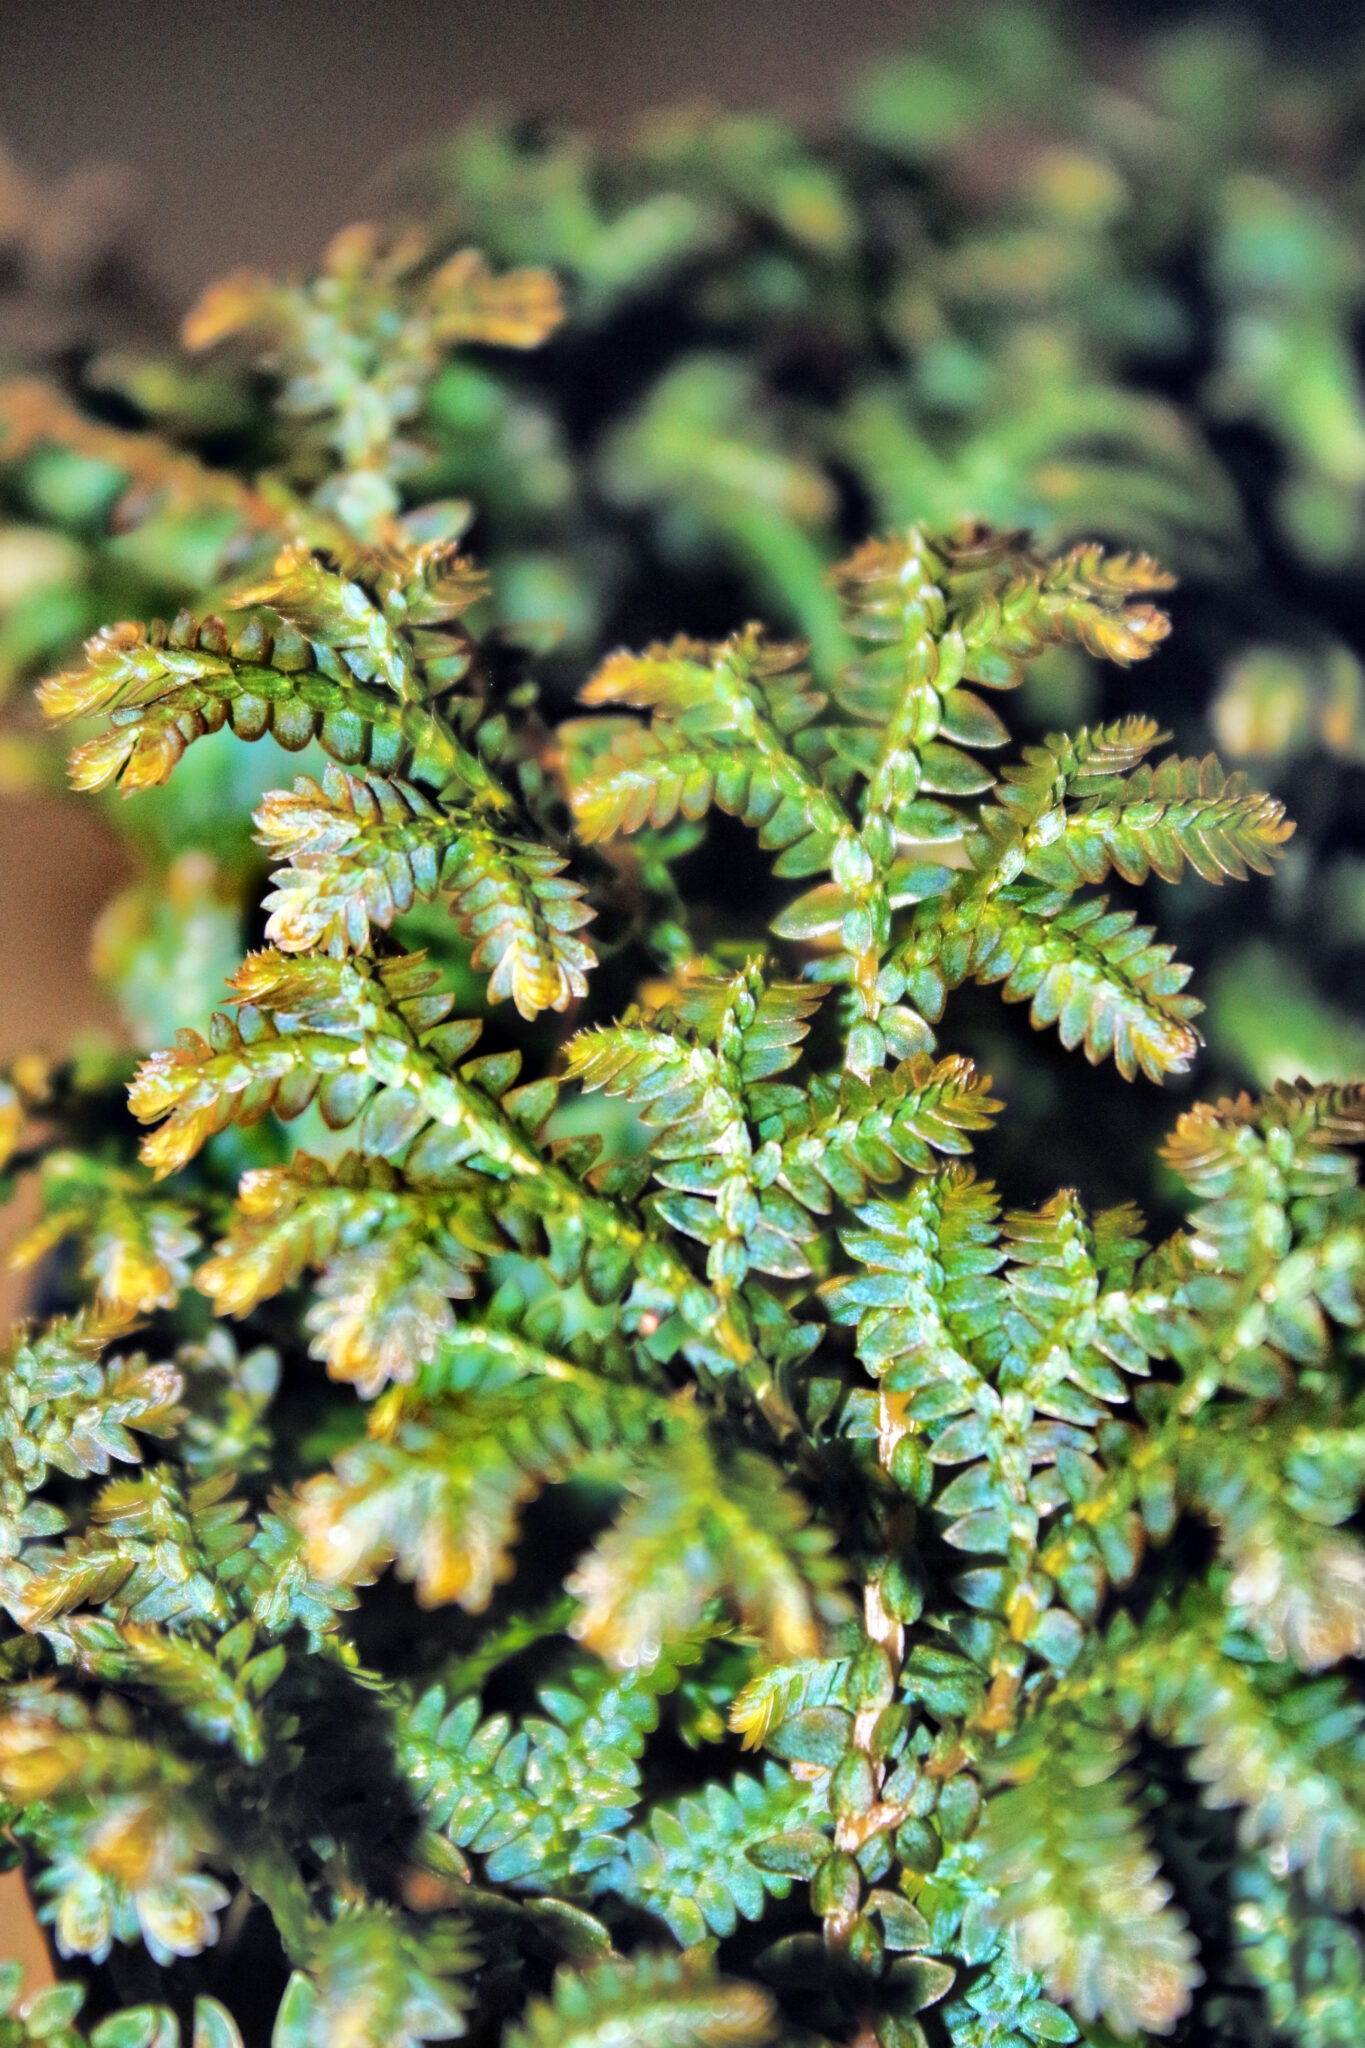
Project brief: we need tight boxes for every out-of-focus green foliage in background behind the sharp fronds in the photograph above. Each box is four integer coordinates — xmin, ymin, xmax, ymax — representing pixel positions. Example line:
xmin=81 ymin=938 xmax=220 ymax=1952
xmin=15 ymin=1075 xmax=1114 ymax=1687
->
xmin=0 ymin=4 xmax=1365 ymax=1200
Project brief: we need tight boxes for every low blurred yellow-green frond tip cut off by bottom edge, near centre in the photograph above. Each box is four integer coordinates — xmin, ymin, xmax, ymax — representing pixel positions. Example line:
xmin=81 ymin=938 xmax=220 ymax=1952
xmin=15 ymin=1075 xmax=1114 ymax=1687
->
xmin=508 ymin=1950 xmax=778 ymax=2048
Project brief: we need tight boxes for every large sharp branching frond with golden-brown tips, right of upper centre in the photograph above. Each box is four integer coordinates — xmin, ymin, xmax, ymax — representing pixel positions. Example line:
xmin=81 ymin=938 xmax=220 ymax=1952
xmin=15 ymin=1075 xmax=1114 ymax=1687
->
xmin=561 ymin=526 xmax=1291 ymax=1079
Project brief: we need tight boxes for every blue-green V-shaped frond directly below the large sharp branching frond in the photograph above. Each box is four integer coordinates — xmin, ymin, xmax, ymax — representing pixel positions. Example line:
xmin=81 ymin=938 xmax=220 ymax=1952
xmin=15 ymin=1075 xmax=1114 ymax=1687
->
xmin=823 ymin=1167 xmax=1150 ymax=1673
